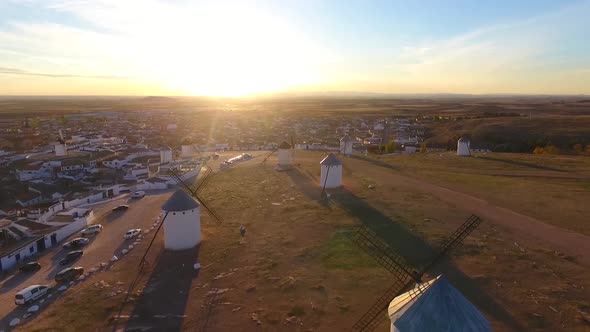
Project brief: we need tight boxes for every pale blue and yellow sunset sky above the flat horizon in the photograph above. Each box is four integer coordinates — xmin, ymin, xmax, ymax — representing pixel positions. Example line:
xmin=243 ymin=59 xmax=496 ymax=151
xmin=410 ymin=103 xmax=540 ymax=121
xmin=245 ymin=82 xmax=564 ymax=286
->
xmin=0 ymin=0 xmax=590 ymax=95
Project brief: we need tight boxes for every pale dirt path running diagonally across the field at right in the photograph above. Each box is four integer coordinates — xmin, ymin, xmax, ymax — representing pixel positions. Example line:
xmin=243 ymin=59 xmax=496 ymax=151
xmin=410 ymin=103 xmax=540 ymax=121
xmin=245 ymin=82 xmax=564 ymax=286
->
xmin=347 ymin=159 xmax=590 ymax=266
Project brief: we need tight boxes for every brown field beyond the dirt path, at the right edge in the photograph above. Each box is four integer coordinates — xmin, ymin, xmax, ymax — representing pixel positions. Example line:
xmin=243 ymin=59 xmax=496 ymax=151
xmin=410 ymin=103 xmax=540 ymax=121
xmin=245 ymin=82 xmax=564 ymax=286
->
xmin=360 ymin=152 xmax=590 ymax=235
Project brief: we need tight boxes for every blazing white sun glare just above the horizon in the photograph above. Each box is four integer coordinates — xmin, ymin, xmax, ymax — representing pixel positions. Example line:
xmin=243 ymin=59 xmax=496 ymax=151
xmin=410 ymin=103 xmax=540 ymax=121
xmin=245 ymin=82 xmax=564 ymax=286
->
xmin=132 ymin=7 xmax=317 ymax=96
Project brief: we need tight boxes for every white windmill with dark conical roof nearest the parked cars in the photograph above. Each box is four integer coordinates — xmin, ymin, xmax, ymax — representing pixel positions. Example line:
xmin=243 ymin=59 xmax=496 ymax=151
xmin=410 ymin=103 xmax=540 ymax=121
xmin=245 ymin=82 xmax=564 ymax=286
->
xmin=162 ymin=189 xmax=201 ymax=250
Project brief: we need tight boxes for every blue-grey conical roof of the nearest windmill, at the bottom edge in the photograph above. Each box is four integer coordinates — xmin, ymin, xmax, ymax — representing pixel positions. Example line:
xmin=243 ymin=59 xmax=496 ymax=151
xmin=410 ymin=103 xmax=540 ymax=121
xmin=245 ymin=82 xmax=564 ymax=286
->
xmin=387 ymin=276 xmax=492 ymax=332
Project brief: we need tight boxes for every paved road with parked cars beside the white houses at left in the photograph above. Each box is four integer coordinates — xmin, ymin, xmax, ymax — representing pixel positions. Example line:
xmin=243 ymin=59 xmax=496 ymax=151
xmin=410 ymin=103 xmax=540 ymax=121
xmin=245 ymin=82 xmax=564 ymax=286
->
xmin=0 ymin=190 xmax=172 ymax=330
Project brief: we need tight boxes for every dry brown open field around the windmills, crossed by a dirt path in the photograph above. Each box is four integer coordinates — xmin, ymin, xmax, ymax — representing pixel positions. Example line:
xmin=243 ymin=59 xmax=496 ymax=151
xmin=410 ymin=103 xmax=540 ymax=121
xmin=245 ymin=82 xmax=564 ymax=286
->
xmin=20 ymin=151 xmax=590 ymax=331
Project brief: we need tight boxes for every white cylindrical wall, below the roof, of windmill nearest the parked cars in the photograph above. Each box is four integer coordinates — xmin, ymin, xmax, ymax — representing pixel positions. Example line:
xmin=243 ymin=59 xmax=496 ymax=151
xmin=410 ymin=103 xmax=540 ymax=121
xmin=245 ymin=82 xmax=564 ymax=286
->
xmin=164 ymin=207 xmax=201 ymax=250
